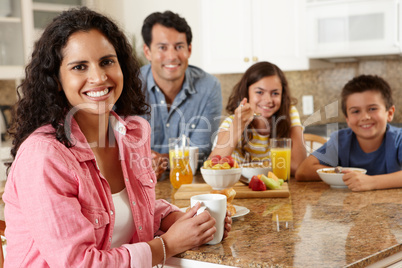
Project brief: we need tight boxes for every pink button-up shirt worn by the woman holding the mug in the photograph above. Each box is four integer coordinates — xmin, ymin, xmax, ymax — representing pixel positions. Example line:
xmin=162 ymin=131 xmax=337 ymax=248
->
xmin=3 ymin=113 xmax=179 ymax=267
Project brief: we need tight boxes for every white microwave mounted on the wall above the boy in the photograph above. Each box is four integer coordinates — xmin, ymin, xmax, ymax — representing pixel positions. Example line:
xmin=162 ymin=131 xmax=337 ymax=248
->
xmin=306 ymin=0 xmax=402 ymax=59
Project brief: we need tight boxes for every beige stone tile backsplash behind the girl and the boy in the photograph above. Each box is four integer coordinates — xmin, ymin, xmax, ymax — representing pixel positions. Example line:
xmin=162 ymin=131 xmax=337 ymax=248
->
xmin=216 ymin=59 xmax=402 ymax=126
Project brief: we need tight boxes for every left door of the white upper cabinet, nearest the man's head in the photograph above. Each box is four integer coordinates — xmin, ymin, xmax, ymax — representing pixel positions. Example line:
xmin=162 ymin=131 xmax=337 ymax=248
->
xmin=201 ymin=0 xmax=252 ymax=73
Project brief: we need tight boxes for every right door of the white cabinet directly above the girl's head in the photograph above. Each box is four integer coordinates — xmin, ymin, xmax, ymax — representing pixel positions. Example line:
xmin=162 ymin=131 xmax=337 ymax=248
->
xmin=251 ymin=0 xmax=308 ymax=70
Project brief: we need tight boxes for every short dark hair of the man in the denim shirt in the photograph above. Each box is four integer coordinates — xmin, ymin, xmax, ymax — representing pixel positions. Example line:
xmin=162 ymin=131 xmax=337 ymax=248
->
xmin=141 ymin=11 xmax=193 ymax=47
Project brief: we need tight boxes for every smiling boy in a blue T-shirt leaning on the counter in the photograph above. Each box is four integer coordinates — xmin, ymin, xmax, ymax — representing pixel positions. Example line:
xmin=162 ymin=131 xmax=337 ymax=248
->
xmin=296 ymin=75 xmax=402 ymax=191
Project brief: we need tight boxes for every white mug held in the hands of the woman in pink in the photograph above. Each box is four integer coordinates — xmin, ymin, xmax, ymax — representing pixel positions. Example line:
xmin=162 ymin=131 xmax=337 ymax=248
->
xmin=190 ymin=194 xmax=226 ymax=245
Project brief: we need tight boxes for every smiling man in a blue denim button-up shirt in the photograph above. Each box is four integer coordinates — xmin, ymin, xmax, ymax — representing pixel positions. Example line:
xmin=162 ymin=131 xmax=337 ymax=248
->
xmin=141 ymin=11 xmax=222 ymax=178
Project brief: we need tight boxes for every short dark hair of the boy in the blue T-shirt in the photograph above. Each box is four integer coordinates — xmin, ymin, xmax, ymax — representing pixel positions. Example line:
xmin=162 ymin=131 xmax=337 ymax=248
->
xmin=341 ymin=75 xmax=394 ymax=117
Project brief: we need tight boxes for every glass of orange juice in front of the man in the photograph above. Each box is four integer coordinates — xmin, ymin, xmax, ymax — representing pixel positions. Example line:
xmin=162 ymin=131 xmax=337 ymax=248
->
xmin=169 ymin=135 xmax=193 ymax=189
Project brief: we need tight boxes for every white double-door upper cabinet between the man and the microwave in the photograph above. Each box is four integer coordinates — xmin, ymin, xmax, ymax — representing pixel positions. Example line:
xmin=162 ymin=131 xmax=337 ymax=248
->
xmin=200 ymin=0 xmax=309 ymax=73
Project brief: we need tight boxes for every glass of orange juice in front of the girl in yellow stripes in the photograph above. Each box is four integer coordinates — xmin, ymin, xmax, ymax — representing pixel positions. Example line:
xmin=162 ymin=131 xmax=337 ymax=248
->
xmin=269 ymin=138 xmax=292 ymax=181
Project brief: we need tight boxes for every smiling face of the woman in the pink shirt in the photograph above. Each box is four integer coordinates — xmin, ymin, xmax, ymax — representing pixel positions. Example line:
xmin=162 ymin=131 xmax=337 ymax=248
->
xmin=60 ymin=30 xmax=123 ymax=114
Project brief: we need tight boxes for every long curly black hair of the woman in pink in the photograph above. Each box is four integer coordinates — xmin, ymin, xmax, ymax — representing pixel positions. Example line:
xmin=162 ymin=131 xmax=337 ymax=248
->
xmin=9 ymin=7 xmax=149 ymax=165
